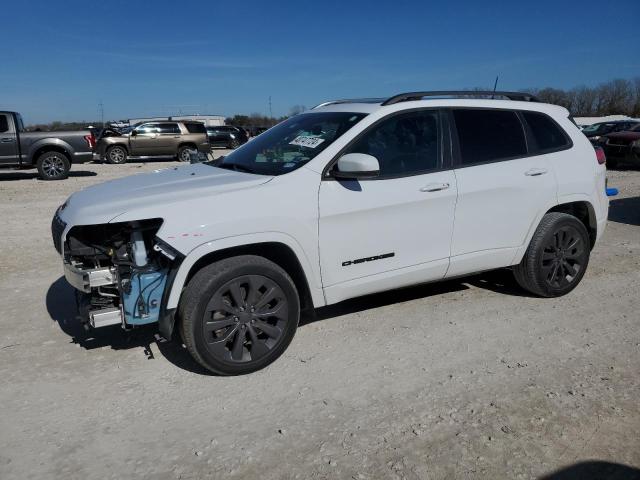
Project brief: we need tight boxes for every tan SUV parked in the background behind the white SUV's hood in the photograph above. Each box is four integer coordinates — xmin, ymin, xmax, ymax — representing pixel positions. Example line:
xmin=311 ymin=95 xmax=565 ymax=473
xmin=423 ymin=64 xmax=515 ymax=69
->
xmin=96 ymin=121 xmax=211 ymax=163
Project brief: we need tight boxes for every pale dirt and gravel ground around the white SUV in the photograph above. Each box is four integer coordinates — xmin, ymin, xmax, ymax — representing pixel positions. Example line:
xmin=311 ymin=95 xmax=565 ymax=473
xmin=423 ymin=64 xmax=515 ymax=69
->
xmin=0 ymin=156 xmax=640 ymax=480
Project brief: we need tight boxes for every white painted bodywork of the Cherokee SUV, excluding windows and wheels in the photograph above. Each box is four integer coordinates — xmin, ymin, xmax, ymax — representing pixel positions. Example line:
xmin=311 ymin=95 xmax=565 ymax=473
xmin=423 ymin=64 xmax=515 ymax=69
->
xmin=55 ymin=99 xmax=608 ymax=316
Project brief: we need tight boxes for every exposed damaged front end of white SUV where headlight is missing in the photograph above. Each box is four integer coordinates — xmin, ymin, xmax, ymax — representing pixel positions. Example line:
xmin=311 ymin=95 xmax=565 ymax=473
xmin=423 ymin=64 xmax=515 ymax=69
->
xmin=64 ymin=219 xmax=181 ymax=328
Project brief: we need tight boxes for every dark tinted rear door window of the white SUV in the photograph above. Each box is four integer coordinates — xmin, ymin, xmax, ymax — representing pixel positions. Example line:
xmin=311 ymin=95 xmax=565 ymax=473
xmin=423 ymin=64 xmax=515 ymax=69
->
xmin=453 ymin=108 xmax=527 ymax=166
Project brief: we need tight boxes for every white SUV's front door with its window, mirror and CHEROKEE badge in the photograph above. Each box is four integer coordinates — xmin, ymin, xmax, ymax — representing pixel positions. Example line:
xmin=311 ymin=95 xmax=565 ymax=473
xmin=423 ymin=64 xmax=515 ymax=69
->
xmin=319 ymin=109 xmax=456 ymax=303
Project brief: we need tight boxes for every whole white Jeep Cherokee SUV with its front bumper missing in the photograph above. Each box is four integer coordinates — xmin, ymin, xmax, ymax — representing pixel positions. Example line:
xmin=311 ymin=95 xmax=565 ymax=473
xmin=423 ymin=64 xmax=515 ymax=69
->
xmin=52 ymin=92 xmax=608 ymax=375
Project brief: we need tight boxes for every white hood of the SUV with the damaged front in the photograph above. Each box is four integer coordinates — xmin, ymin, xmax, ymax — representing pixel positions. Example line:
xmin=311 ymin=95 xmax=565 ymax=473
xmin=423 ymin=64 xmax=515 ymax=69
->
xmin=60 ymin=164 xmax=273 ymax=225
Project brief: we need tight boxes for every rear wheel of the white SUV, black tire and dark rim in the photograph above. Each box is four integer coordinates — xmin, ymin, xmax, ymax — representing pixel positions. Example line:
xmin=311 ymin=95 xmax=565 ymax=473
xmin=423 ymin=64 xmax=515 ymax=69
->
xmin=513 ymin=212 xmax=591 ymax=297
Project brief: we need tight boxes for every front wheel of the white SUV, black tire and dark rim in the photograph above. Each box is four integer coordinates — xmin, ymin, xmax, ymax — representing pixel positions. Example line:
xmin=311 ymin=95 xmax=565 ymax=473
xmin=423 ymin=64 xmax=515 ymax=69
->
xmin=179 ymin=255 xmax=300 ymax=375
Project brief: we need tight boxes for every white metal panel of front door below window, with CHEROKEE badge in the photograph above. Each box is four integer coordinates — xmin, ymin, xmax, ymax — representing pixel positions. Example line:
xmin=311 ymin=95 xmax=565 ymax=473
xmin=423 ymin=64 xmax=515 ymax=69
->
xmin=319 ymin=171 xmax=457 ymax=298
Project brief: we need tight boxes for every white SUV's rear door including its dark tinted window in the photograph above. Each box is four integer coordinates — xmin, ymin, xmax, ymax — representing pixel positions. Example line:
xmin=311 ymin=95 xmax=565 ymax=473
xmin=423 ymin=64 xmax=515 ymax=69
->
xmin=447 ymin=108 xmax=557 ymax=277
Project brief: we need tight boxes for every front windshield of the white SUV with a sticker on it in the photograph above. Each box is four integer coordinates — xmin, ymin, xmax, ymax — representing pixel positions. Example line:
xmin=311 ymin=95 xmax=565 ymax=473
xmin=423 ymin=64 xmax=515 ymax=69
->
xmin=212 ymin=112 xmax=366 ymax=175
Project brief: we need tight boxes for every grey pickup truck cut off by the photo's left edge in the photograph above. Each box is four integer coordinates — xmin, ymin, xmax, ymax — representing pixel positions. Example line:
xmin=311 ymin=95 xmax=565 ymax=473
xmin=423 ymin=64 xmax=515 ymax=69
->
xmin=0 ymin=111 xmax=95 ymax=180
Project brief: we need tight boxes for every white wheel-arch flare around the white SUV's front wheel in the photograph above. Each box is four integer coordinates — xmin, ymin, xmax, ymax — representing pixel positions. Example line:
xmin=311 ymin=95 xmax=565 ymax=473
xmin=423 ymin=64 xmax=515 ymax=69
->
xmin=165 ymin=232 xmax=326 ymax=310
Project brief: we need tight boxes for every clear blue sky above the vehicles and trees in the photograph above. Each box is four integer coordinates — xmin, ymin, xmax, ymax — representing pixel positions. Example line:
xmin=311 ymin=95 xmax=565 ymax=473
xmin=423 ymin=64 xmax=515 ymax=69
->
xmin=0 ymin=0 xmax=640 ymax=123
